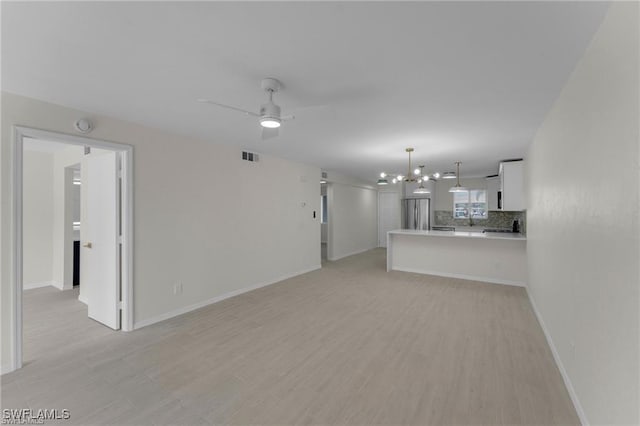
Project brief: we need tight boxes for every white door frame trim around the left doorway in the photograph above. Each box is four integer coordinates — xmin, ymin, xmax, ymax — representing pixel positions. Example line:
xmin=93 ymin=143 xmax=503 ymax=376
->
xmin=10 ymin=126 xmax=133 ymax=373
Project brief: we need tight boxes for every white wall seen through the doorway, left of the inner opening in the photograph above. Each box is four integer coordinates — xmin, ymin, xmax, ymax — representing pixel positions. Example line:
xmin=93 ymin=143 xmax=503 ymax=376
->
xmin=21 ymin=151 xmax=53 ymax=288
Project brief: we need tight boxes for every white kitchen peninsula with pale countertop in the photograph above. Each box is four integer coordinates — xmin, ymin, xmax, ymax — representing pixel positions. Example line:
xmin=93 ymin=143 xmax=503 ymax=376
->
xmin=387 ymin=229 xmax=527 ymax=286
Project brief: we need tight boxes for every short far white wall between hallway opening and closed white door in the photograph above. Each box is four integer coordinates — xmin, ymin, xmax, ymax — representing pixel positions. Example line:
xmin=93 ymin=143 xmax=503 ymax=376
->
xmin=327 ymin=172 xmax=378 ymax=260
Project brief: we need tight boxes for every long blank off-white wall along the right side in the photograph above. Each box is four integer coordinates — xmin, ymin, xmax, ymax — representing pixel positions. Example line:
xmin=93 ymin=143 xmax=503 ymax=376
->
xmin=526 ymin=2 xmax=640 ymax=424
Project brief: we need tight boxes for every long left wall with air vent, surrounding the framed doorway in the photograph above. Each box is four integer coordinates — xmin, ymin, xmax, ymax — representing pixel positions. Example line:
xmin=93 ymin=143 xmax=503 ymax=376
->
xmin=0 ymin=92 xmax=320 ymax=368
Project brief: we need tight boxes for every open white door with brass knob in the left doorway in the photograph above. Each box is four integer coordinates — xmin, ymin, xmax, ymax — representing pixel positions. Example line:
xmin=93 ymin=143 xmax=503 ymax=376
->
xmin=80 ymin=152 xmax=120 ymax=330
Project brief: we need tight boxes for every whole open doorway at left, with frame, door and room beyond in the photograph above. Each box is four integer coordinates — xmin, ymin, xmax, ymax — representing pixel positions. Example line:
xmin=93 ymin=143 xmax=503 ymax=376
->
xmin=13 ymin=129 xmax=133 ymax=368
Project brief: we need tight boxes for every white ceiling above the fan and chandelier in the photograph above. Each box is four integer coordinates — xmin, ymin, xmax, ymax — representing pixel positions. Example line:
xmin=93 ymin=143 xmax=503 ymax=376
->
xmin=2 ymin=1 xmax=607 ymax=181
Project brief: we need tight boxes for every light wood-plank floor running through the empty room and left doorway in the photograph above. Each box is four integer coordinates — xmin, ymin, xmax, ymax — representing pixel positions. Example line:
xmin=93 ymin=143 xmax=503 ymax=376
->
xmin=2 ymin=249 xmax=579 ymax=425
